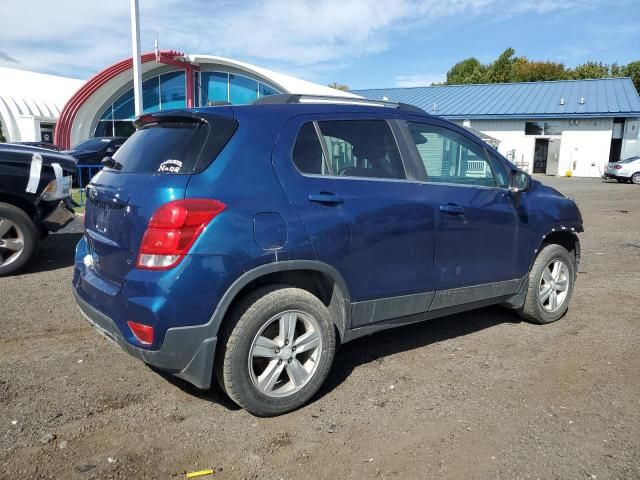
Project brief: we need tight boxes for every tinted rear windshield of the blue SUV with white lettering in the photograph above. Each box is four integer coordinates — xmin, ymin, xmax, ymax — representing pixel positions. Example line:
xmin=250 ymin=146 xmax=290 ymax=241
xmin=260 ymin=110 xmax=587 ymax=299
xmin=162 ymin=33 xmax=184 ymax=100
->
xmin=113 ymin=118 xmax=236 ymax=175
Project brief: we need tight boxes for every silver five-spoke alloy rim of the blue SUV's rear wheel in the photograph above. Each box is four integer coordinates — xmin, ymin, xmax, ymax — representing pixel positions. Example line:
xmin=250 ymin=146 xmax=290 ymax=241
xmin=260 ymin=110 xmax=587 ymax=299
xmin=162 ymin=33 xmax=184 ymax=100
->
xmin=248 ymin=310 xmax=322 ymax=397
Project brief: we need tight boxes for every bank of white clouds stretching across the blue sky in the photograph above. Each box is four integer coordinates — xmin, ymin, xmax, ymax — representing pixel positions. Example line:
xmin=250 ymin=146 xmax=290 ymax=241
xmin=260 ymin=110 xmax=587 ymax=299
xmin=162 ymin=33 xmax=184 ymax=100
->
xmin=0 ymin=0 xmax=608 ymax=81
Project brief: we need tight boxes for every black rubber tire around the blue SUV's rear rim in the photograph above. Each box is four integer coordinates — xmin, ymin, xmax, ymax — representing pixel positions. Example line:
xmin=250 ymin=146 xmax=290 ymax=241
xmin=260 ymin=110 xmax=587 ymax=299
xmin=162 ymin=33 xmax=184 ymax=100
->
xmin=214 ymin=285 xmax=336 ymax=416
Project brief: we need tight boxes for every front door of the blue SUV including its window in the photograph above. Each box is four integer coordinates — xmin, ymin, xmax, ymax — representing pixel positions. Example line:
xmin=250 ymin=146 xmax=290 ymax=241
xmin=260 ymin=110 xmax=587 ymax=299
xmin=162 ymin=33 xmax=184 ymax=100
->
xmin=405 ymin=120 xmax=522 ymax=310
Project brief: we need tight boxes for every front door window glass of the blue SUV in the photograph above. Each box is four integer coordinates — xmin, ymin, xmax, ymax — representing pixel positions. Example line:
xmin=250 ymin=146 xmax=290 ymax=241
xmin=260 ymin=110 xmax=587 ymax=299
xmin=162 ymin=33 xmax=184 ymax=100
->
xmin=408 ymin=122 xmax=503 ymax=186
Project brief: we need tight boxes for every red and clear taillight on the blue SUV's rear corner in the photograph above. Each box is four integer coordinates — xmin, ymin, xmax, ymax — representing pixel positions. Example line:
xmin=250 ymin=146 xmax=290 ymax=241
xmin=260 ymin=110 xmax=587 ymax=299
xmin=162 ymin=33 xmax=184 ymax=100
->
xmin=136 ymin=199 xmax=225 ymax=270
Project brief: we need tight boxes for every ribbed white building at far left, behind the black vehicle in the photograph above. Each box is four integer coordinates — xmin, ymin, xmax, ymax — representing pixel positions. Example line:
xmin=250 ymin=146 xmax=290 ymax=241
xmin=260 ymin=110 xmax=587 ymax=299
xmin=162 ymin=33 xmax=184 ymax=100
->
xmin=0 ymin=67 xmax=84 ymax=143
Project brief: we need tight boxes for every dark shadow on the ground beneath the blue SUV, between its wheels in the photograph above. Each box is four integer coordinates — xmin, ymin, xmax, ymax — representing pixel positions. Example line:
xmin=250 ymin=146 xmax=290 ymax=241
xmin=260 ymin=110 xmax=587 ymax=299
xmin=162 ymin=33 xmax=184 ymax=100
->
xmin=315 ymin=306 xmax=521 ymax=399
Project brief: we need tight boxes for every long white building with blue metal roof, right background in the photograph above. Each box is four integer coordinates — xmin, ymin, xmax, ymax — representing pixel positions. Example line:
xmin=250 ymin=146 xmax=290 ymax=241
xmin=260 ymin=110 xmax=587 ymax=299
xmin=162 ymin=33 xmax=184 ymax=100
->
xmin=353 ymin=78 xmax=640 ymax=177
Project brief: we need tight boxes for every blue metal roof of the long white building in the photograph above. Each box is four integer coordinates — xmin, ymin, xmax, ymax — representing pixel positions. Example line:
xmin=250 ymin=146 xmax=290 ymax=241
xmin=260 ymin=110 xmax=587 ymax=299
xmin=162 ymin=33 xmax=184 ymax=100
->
xmin=351 ymin=78 xmax=640 ymax=119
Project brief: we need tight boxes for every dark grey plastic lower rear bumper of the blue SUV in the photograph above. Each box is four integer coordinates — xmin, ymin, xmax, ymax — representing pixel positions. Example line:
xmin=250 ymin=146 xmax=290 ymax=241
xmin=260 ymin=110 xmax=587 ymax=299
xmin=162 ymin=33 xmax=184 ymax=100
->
xmin=74 ymin=289 xmax=217 ymax=389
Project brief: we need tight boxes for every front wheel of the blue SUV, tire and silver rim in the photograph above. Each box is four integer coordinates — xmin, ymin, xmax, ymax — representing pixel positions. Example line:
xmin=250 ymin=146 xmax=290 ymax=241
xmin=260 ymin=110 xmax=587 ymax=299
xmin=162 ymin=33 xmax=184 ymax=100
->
xmin=518 ymin=244 xmax=576 ymax=324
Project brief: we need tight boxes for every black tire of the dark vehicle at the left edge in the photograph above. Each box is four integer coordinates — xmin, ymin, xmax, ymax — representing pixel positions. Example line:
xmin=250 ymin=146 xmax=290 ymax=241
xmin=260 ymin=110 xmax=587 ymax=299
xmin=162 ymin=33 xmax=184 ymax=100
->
xmin=0 ymin=202 xmax=40 ymax=276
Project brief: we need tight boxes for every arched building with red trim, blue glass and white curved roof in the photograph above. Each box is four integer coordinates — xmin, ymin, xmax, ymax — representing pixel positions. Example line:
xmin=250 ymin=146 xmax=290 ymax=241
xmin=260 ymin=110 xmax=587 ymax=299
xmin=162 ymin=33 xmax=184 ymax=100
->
xmin=55 ymin=51 xmax=355 ymax=148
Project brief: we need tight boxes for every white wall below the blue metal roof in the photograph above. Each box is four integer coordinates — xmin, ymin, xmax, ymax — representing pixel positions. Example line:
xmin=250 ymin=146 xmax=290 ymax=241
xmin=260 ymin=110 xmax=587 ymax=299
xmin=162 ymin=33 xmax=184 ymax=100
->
xmin=470 ymin=118 xmax=613 ymax=177
